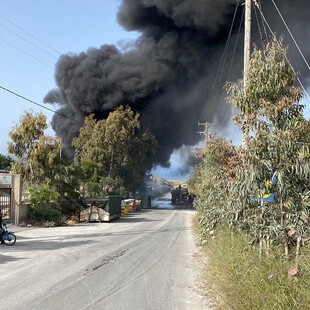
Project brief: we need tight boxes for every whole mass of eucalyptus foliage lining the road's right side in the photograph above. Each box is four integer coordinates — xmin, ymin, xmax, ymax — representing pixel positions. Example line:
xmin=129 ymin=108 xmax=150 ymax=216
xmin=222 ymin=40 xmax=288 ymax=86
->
xmin=194 ymin=38 xmax=310 ymax=263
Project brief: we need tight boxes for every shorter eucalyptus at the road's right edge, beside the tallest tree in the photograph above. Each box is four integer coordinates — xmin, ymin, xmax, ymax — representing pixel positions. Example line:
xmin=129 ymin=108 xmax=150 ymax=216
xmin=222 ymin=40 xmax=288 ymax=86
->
xmin=189 ymin=137 xmax=237 ymax=240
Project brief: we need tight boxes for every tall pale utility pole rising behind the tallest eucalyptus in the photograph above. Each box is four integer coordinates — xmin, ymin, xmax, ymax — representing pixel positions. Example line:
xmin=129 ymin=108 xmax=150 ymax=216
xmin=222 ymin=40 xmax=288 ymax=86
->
xmin=242 ymin=0 xmax=252 ymax=148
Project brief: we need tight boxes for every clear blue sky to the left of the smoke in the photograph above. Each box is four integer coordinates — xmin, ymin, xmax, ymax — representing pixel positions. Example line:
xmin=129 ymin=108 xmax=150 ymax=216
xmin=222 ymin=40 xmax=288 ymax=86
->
xmin=0 ymin=0 xmax=138 ymax=154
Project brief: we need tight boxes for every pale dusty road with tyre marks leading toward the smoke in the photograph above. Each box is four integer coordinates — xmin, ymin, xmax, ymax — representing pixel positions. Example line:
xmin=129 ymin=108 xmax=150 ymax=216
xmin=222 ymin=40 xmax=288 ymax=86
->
xmin=0 ymin=202 xmax=208 ymax=310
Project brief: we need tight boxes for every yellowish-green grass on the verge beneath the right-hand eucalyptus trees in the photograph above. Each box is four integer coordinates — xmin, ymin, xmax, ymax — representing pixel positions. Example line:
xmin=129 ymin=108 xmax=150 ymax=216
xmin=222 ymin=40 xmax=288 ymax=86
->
xmin=197 ymin=224 xmax=310 ymax=310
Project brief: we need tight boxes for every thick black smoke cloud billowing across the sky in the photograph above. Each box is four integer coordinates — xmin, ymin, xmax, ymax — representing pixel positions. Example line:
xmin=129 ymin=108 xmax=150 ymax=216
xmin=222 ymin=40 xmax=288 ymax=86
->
xmin=44 ymin=0 xmax=310 ymax=166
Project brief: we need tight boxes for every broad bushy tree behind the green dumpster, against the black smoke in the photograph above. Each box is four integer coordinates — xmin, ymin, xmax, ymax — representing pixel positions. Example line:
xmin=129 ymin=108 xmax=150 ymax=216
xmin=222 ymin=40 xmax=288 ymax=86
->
xmin=72 ymin=106 xmax=156 ymax=194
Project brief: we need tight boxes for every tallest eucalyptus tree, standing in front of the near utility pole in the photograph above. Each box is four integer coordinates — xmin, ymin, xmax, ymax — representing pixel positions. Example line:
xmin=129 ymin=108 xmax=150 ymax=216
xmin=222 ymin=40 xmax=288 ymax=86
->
xmin=227 ymin=38 xmax=310 ymax=255
